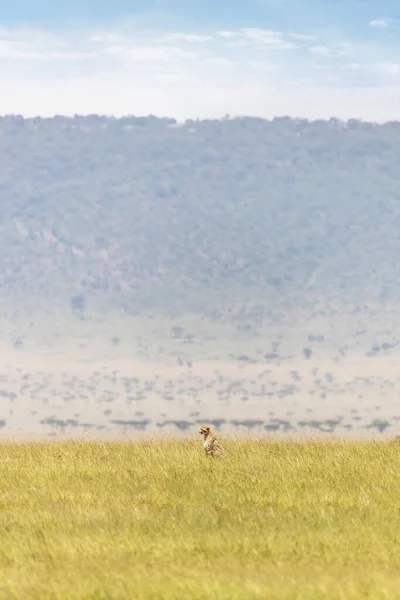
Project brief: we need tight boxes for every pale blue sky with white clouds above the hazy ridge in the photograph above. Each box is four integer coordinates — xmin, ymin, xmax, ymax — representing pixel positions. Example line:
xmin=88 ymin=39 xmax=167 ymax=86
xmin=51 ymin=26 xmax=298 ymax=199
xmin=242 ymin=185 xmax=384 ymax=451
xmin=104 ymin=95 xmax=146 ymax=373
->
xmin=0 ymin=0 xmax=400 ymax=121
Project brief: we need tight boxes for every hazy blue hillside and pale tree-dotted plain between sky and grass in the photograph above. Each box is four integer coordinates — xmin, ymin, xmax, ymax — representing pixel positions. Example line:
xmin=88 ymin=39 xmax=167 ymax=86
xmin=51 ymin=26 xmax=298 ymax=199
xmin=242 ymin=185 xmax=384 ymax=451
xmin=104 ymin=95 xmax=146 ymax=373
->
xmin=0 ymin=115 xmax=400 ymax=439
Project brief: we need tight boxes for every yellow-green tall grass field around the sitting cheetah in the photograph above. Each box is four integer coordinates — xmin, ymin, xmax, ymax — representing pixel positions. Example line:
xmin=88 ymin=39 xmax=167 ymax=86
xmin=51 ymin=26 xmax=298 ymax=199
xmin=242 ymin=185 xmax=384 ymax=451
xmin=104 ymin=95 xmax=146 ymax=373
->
xmin=0 ymin=440 xmax=400 ymax=600
